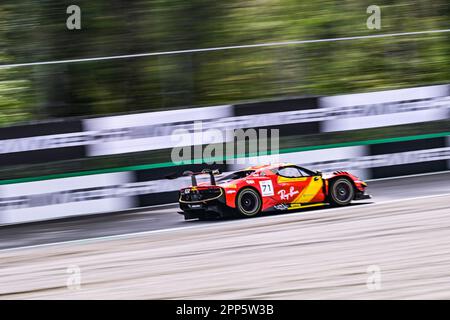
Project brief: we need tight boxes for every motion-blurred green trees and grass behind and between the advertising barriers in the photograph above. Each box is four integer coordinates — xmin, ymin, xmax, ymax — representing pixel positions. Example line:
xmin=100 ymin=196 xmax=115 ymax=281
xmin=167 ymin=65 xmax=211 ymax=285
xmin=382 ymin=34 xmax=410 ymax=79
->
xmin=0 ymin=0 xmax=450 ymax=178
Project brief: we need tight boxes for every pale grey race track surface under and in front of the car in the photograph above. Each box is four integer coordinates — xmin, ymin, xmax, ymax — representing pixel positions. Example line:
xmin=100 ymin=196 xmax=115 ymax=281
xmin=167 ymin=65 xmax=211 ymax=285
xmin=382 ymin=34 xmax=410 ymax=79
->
xmin=0 ymin=173 xmax=450 ymax=299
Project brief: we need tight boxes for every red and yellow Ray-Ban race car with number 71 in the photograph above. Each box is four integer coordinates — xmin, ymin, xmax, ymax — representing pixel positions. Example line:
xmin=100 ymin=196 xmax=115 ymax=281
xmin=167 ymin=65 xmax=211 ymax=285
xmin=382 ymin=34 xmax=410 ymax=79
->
xmin=179 ymin=163 xmax=370 ymax=220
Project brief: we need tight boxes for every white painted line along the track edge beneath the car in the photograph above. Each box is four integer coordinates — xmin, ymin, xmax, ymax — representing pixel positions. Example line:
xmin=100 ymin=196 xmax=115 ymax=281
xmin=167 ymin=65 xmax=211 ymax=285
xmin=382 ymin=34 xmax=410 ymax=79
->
xmin=0 ymin=193 xmax=450 ymax=253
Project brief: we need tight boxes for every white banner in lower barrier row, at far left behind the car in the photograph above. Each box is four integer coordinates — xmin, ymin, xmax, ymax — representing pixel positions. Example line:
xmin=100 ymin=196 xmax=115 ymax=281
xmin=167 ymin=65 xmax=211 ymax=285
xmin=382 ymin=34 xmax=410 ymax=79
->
xmin=0 ymin=172 xmax=135 ymax=224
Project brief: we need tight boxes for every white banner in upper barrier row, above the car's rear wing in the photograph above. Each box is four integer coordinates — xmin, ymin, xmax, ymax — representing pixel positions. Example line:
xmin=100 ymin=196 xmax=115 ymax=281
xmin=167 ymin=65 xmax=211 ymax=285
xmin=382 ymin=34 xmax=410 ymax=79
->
xmin=83 ymin=106 xmax=233 ymax=156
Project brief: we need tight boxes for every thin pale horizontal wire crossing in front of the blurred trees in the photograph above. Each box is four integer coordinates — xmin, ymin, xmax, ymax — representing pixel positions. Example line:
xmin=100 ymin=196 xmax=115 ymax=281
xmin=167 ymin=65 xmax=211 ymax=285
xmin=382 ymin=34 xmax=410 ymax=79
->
xmin=0 ymin=29 xmax=450 ymax=69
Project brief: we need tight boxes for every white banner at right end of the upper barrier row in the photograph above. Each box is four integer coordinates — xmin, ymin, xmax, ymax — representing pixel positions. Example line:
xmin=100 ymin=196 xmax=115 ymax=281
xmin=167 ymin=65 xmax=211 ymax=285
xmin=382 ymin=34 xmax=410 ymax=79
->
xmin=319 ymin=85 xmax=450 ymax=132
